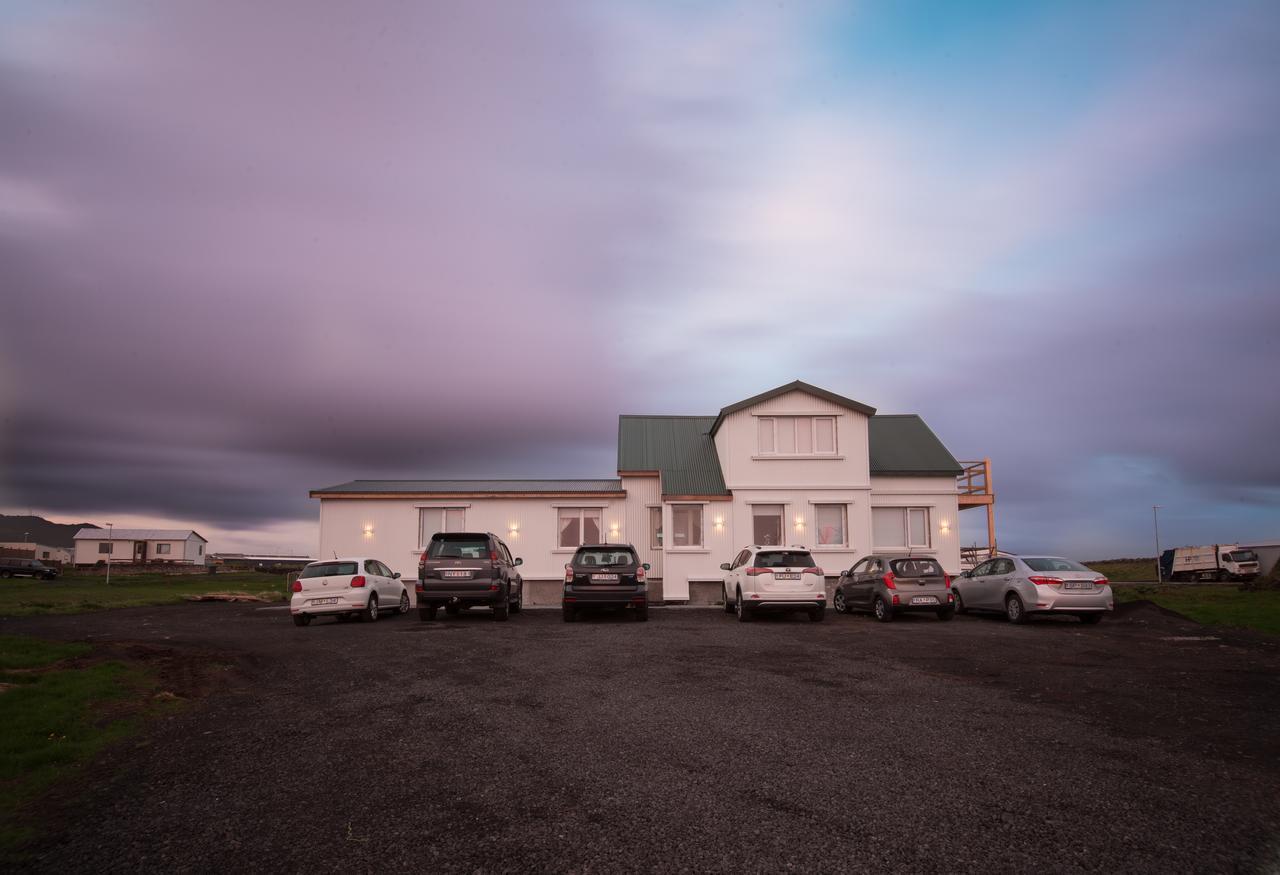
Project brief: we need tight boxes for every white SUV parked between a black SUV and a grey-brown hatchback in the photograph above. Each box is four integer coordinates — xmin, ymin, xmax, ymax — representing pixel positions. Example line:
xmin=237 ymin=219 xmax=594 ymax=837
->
xmin=721 ymin=544 xmax=827 ymax=623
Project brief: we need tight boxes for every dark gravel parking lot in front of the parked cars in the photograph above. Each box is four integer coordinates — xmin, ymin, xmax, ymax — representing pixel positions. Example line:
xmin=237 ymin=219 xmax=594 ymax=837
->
xmin=0 ymin=605 xmax=1280 ymax=872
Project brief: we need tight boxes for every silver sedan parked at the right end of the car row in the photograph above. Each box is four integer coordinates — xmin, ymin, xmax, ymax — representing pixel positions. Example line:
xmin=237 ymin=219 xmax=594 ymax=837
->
xmin=952 ymin=554 xmax=1115 ymax=623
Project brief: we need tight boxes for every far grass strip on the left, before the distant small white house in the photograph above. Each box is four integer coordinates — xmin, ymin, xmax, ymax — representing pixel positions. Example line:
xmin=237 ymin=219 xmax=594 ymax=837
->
xmin=0 ymin=572 xmax=287 ymax=617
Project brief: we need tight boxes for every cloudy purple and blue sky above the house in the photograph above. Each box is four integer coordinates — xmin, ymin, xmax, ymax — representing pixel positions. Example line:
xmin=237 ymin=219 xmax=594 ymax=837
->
xmin=0 ymin=0 xmax=1280 ymax=558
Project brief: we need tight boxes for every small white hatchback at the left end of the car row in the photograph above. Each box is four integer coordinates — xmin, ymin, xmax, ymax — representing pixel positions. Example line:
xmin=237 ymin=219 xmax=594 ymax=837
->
xmin=289 ymin=558 xmax=410 ymax=626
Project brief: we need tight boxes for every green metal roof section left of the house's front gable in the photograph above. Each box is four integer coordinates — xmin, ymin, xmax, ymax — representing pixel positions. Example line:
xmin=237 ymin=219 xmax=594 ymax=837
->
xmin=618 ymin=414 xmax=730 ymax=496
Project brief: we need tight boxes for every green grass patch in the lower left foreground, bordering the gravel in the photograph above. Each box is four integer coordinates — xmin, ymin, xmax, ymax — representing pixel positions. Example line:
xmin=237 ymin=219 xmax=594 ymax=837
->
xmin=0 ymin=636 xmax=172 ymax=866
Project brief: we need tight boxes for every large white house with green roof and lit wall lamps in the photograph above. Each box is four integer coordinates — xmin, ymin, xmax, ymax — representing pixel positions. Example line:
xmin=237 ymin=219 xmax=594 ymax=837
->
xmin=311 ymin=381 xmax=961 ymax=604
